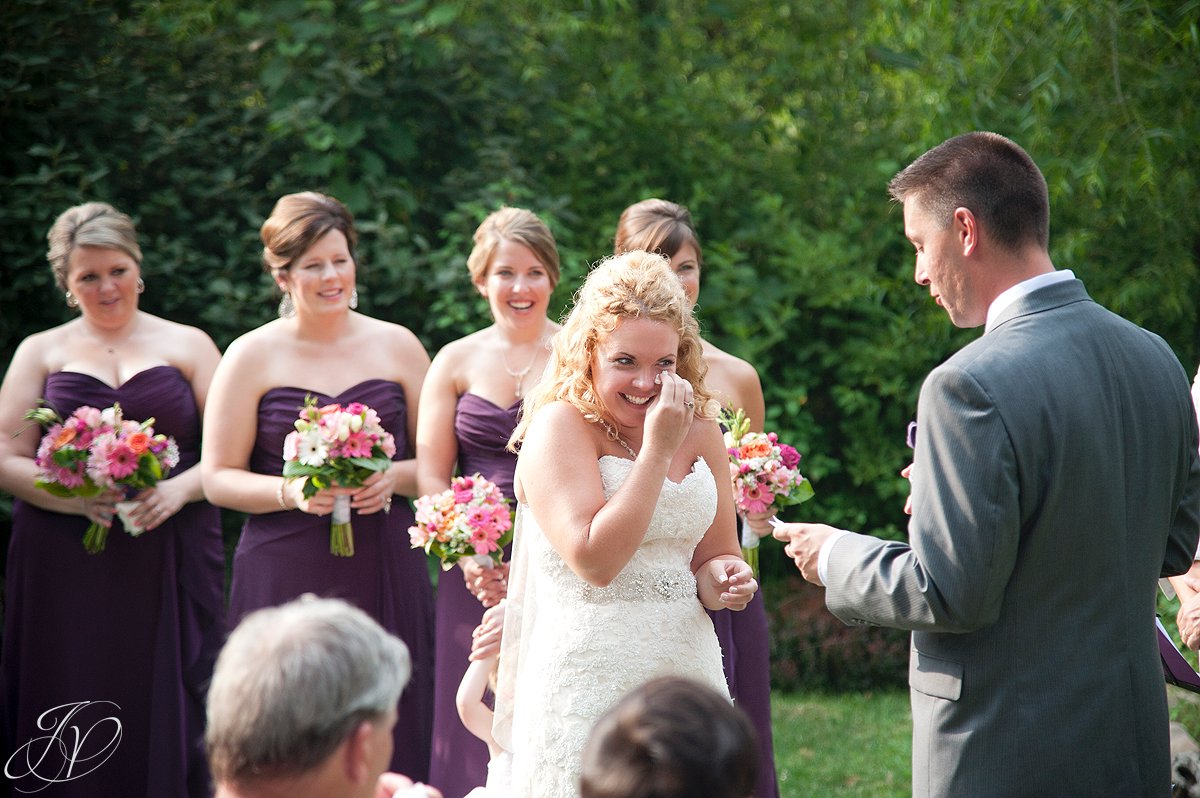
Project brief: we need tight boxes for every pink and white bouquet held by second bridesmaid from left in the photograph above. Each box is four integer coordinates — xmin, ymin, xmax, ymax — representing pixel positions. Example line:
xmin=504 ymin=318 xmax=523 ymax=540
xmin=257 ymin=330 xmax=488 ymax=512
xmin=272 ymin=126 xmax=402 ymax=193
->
xmin=283 ymin=396 xmax=396 ymax=557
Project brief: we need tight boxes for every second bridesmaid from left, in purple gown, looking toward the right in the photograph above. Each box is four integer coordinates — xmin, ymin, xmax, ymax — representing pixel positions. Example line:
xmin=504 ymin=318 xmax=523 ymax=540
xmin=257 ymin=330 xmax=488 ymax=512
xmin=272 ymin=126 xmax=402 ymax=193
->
xmin=203 ymin=192 xmax=433 ymax=781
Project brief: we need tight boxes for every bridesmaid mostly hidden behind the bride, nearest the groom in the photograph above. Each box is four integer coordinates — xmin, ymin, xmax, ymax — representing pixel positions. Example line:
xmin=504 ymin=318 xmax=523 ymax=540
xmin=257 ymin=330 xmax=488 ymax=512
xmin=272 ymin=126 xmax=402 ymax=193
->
xmin=613 ymin=199 xmax=779 ymax=798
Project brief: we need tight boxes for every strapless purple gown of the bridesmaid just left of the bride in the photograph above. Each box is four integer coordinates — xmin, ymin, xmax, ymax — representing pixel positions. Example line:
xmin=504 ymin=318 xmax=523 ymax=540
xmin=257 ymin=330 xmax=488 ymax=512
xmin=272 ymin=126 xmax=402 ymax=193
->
xmin=430 ymin=394 xmax=521 ymax=798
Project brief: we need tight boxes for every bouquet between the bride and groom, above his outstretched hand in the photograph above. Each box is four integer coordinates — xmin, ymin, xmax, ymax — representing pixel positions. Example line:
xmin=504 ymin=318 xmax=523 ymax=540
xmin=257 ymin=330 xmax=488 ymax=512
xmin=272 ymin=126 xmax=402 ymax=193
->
xmin=721 ymin=409 xmax=814 ymax=574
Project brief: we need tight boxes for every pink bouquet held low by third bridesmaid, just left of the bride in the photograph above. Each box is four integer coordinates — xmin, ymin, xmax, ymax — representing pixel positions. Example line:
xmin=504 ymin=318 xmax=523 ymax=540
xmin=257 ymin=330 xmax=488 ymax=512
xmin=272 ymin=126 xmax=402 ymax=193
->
xmin=408 ymin=474 xmax=512 ymax=571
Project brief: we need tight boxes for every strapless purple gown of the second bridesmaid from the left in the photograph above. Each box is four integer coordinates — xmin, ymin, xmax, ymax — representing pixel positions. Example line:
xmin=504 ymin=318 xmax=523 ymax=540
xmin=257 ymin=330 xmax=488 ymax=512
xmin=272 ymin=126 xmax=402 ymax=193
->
xmin=229 ymin=379 xmax=433 ymax=780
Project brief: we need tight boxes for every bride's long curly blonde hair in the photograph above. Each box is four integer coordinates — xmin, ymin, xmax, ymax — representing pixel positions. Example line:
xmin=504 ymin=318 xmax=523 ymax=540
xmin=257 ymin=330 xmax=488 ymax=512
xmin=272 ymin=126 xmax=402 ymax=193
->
xmin=509 ymin=250 xmax=718 ymax=451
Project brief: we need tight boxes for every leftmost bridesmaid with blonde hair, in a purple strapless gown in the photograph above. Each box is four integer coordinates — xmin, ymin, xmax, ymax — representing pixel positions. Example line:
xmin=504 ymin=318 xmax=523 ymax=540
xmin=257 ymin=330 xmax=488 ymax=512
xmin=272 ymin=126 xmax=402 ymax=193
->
xmin=0 ymin=203 xmax=224 ymax=797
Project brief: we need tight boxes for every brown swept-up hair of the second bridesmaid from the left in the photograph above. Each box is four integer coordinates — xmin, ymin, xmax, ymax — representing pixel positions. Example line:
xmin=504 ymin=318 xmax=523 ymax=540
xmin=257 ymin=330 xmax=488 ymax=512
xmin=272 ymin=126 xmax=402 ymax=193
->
xmin=259 ymin=191 xmax=359 ymax=274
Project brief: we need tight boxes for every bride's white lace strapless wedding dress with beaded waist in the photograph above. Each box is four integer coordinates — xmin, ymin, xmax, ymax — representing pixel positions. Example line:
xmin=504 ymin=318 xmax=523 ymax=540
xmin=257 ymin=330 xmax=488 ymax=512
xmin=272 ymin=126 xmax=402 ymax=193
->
xmin=496 ymin=455 xmax=728 ymax=798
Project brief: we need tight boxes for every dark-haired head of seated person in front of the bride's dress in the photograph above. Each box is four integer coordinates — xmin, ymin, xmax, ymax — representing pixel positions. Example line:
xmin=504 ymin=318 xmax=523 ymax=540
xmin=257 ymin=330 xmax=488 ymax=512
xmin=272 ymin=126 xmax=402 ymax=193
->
xmin=580 ymin=677 xmax=758 ymax=798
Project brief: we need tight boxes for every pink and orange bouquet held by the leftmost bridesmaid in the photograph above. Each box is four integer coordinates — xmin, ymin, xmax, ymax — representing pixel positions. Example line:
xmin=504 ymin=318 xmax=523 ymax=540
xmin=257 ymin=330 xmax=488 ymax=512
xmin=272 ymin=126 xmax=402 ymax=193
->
xmin=25 ymin=404 xmax=179 ymax=554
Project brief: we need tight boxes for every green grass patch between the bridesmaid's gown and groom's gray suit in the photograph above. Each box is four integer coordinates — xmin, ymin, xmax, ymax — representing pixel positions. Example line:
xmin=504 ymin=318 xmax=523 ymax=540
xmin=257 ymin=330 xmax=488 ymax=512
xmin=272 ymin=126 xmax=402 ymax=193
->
xmin=770 ymin=690 xmax=912 ymax=798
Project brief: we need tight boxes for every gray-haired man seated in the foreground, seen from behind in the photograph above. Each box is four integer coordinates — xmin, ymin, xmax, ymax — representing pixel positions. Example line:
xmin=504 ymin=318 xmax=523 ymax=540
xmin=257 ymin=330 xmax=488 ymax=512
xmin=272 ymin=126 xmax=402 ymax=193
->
xmin=205 ymin=595 xmax=440 ymax=798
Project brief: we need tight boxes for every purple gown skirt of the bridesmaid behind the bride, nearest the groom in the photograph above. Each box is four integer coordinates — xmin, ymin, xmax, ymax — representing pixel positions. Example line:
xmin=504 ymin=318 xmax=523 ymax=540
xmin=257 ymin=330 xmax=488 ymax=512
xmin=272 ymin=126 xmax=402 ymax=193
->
xmin=708 ymin=521 xmax=779 ymax=798
